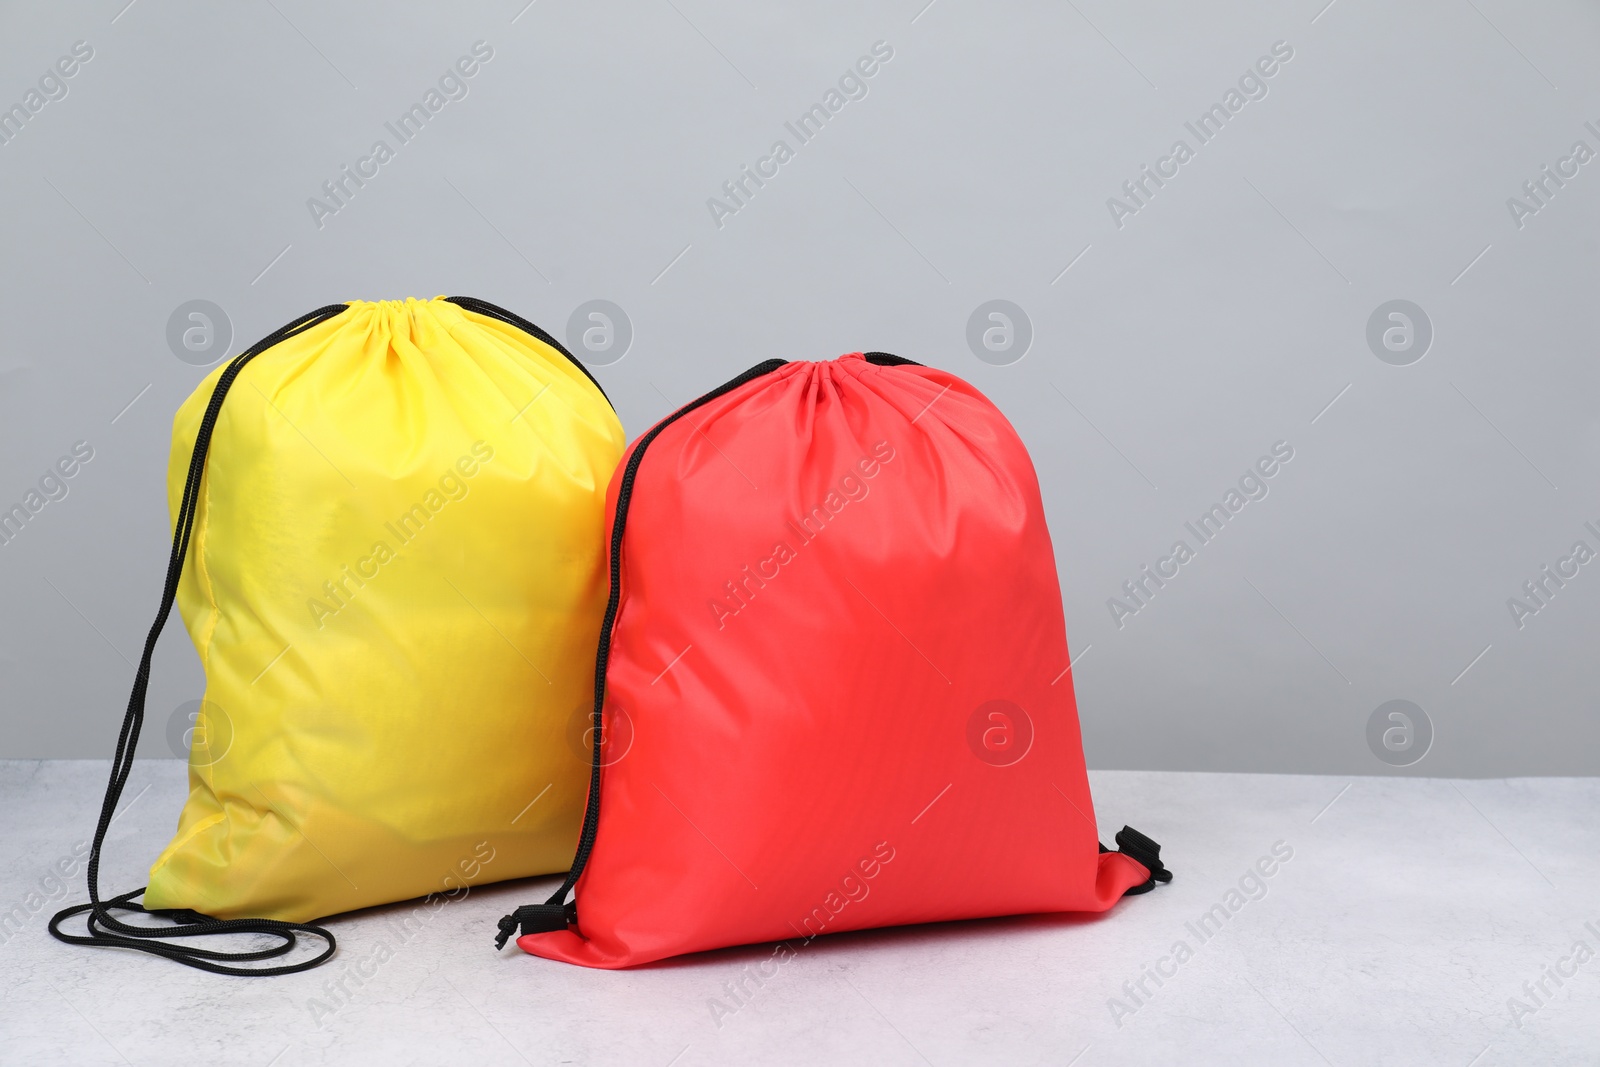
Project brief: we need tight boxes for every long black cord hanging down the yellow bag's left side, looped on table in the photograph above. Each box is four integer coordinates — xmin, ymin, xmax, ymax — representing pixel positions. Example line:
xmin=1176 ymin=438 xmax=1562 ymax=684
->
xmin=50 ymin=304 xmax=347 ymax=976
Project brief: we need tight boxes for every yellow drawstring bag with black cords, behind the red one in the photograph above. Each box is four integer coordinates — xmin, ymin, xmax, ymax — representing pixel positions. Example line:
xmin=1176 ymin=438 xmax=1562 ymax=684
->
xmin=53 ymin=298 xmax=624 ymax=973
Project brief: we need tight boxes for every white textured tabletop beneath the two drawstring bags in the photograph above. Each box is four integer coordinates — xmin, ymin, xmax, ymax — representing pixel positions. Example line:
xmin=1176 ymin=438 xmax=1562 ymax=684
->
xmin=0 ymin=760 xmax=1600 ymax=1067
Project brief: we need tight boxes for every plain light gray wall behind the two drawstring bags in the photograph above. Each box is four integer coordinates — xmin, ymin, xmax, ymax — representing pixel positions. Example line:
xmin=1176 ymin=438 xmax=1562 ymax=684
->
xmin=0 ymin=0 xmax=1600 ymax=774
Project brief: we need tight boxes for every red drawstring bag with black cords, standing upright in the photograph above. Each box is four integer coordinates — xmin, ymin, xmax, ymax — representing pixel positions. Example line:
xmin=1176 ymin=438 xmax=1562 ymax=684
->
xmin=498 ymin=352 xmax=1171 ymax=968
